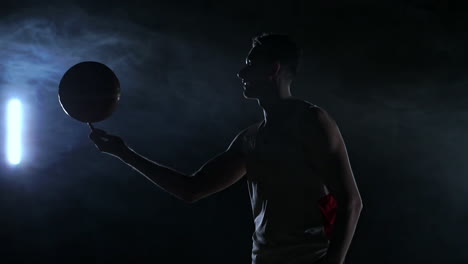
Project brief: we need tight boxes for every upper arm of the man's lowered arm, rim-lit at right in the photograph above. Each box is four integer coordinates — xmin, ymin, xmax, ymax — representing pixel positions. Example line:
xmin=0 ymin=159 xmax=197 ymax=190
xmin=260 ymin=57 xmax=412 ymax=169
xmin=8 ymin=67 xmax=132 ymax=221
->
xmin=303 ymin=107 xmax=362 ymax=206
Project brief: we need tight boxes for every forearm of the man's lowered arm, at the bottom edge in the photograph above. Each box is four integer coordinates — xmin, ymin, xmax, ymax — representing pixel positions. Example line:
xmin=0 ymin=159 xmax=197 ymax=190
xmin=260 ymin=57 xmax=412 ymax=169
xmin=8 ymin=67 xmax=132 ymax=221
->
xmin=327 ymin=205 xmax=362 ymax=264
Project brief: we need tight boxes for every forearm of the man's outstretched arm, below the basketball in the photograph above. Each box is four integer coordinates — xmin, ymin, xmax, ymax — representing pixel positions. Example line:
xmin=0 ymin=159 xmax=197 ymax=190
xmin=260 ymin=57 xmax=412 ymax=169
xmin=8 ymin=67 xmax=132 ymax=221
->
xmin=118 ymin=148 xmax=193 ymax=201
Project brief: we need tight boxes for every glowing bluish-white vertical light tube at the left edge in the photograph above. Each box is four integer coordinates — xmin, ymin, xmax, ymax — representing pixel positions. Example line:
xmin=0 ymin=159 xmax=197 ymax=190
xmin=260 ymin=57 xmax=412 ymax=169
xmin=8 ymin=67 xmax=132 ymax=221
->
xmin=6 ymin=99 xmax=23 ymax=165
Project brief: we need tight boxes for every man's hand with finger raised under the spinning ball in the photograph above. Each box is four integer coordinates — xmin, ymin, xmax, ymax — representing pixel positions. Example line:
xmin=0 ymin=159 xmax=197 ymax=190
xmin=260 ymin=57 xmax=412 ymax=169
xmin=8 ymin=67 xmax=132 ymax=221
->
xmin=89 ymin=125 xmax=128 ymax=158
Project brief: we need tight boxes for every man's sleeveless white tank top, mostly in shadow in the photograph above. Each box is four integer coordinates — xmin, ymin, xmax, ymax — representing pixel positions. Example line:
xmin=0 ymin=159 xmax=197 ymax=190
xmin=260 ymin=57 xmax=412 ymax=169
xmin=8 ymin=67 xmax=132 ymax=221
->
xmin=242 ymin=101 xmax=329 ymax=264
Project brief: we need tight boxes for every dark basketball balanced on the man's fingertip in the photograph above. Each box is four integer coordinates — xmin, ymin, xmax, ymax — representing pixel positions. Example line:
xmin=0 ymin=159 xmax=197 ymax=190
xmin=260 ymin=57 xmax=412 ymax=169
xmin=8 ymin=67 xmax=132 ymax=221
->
xmin=58 ymin=61 xmax=120 ymax=123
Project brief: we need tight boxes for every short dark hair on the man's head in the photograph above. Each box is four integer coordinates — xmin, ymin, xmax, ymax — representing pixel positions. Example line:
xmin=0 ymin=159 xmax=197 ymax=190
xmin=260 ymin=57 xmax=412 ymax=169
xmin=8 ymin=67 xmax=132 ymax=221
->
xmin=252 ymin=33 xmax=302 ymax=76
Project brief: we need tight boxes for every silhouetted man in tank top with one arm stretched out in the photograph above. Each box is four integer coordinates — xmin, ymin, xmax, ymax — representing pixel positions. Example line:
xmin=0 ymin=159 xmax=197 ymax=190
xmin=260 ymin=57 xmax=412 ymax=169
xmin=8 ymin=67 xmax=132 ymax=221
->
xmin=90 ymin=34 xmax=362 ymax=264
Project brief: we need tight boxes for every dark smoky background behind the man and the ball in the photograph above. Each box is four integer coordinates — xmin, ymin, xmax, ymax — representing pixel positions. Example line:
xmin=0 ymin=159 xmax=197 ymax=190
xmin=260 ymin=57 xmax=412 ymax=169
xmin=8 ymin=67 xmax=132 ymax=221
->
xmin=0 ymin=1 xmax=468 ymax=264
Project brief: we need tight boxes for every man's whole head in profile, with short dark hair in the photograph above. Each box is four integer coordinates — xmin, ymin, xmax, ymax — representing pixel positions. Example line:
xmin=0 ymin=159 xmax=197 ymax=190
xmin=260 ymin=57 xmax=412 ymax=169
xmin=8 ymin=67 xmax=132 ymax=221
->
xmin=237 ymin=33 xmax=301 ymax=100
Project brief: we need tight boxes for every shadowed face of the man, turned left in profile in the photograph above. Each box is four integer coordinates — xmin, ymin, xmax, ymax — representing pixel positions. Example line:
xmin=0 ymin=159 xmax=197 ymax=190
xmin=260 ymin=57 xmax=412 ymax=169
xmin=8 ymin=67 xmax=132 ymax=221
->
xmin=237 ymin=46 xmax=278 ymax=99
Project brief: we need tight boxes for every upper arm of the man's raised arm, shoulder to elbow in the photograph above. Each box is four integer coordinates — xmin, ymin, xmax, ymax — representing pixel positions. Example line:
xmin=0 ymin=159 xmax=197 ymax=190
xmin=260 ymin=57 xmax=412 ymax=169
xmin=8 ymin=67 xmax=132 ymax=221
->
xmin=189 ymin=130 xmax=250 ymax=201
